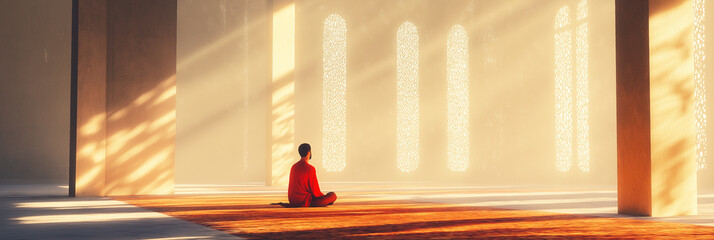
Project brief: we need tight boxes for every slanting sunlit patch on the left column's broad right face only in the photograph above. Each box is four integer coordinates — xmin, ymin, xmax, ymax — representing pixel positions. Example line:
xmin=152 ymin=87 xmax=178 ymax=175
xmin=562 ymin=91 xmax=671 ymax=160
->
xmin=106 ymin=76 xmax=176 ymax=195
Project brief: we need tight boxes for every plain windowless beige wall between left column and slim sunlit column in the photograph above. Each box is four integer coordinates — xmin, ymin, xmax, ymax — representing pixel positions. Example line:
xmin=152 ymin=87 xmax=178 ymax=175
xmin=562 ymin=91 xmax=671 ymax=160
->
xmin=176 ymin=0 xmax=270 ymax=184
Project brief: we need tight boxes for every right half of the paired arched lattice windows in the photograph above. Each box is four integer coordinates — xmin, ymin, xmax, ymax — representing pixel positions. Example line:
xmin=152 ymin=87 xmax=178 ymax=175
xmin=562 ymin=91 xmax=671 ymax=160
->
xmin=576 ymin=0 xmax=590 ymax=172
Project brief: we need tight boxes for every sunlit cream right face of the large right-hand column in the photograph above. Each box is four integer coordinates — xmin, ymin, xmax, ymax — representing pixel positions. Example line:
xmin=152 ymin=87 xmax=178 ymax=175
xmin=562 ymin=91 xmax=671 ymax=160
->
xmin=649 ymin=0 xmax=697 ymax=215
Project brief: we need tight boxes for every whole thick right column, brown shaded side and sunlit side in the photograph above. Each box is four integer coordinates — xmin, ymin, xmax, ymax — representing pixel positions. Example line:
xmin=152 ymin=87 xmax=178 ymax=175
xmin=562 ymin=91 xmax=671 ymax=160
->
xmin=616 ymin=0 xmax=697 ymax=216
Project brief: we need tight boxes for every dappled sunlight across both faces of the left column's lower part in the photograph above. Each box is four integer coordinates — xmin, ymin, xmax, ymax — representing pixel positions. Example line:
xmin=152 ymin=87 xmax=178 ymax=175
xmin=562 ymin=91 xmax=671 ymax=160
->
xmin=77 ymin=76 xmax=176 ymax=195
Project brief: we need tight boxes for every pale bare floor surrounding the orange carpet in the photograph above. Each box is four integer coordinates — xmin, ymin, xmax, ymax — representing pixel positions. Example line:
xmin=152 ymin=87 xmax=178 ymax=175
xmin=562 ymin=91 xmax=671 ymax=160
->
xmin=0 ymin=183 xmax=714 ymax=240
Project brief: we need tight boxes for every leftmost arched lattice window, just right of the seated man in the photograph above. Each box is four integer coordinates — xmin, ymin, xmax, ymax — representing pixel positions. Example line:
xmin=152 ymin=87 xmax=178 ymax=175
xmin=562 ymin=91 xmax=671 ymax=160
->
xmin=322 ymin=14 xmax=347 ymax=172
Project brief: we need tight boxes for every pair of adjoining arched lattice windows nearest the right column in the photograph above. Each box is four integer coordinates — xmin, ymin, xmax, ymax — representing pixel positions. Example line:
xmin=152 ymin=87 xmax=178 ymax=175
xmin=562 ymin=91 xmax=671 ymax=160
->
xmin=555 ymin=0 xmax=590 ymax=172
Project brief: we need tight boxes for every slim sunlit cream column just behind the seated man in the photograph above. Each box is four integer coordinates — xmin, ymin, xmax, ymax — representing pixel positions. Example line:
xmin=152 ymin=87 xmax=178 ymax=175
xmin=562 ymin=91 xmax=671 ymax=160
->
xmin=266 ymin=0 xmax=299 ymax=186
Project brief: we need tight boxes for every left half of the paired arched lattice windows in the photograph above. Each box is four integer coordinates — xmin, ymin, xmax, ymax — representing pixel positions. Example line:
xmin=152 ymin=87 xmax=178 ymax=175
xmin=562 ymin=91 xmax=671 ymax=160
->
xmin=555 ymin=6 xmax=573 ymax=172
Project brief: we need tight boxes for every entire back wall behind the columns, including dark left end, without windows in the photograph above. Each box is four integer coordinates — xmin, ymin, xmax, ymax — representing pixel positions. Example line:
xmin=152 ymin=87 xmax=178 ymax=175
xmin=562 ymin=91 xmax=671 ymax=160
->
xmin=0 ymin=0 xmax=714 ymax=191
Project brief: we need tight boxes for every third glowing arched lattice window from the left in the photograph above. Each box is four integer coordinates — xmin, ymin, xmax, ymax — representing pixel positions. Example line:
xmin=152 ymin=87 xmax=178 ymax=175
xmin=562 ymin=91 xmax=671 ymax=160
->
xmin=446 ymin=25 xmax=469 ymax=172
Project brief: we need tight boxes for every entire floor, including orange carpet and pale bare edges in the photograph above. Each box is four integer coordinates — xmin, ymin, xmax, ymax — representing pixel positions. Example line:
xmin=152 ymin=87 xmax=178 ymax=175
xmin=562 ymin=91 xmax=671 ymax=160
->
xmin=0 ymin=183 xmax=714 ymax=239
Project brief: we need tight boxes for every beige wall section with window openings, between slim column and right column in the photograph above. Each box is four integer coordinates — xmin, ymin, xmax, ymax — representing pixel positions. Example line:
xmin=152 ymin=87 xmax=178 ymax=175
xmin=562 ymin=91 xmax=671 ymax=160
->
xmin=295 ymin=0 xmax=616 ymax=186
